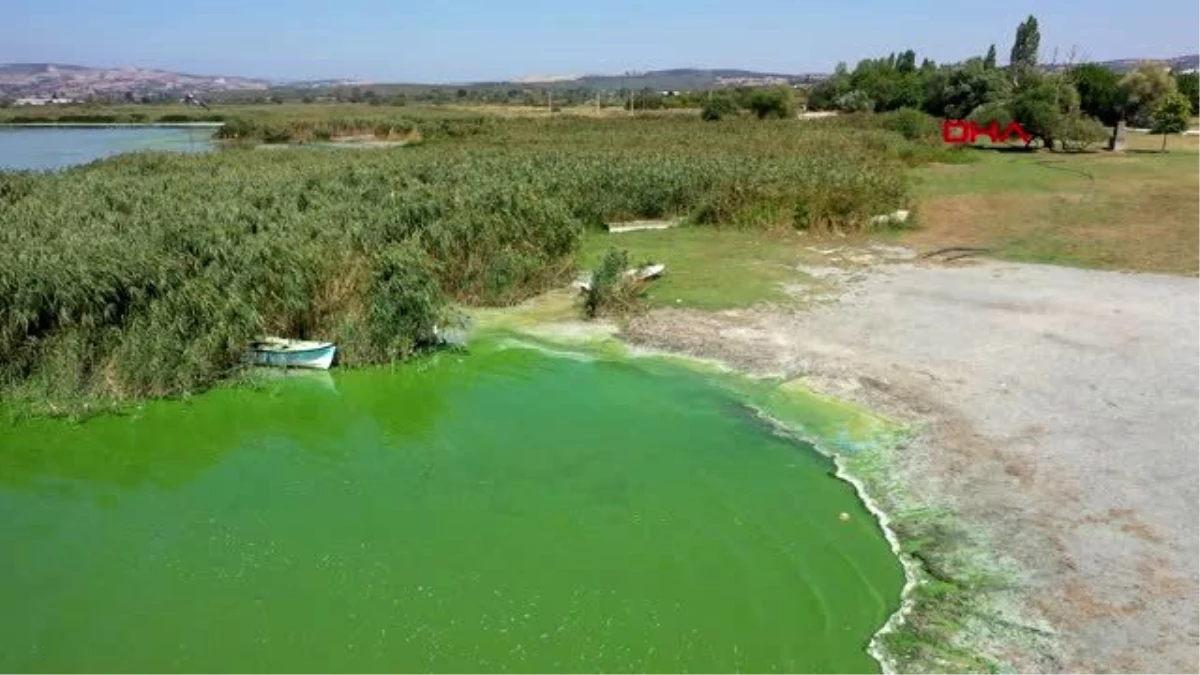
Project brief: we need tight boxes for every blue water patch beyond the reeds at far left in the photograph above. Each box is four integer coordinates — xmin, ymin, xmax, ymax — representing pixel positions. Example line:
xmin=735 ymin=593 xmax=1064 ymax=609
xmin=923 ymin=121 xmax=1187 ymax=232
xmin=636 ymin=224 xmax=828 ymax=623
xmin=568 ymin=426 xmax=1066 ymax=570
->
xmin=0 ymin=127 xmax=214 ymax=171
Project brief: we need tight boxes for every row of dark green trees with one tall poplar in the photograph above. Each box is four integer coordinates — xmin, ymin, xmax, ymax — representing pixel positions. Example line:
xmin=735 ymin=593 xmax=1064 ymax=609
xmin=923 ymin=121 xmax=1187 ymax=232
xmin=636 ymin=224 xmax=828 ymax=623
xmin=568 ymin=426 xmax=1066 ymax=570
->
xmin=809 ymin=17 xmax=1200 ymax=148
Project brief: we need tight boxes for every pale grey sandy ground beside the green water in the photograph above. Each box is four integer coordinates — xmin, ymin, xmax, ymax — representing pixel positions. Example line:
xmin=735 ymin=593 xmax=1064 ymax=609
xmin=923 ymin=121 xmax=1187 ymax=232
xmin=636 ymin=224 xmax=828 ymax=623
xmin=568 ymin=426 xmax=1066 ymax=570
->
xmin=626 ymin=257 xmax=1200 ymax=673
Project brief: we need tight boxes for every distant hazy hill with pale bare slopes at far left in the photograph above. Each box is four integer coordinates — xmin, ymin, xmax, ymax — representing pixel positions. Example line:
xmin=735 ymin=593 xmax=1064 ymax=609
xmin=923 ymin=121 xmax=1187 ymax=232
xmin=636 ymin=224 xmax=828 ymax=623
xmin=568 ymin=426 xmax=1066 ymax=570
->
xmin=0 ymin=64 xmax=270 ymax=98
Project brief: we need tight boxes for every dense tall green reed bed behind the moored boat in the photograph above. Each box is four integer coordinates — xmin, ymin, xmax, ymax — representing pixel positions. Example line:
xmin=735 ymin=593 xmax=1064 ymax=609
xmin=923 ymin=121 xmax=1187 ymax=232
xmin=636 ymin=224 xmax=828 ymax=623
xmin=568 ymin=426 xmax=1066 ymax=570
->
xmin=0 ymin=118 xmax=936 ymax=411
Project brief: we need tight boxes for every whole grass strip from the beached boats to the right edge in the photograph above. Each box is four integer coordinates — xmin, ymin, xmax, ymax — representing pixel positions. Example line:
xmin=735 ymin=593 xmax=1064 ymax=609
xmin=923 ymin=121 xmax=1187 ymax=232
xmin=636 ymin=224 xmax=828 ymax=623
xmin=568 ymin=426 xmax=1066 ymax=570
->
xmin=571 ymin=136 xmax=1200 ymax=310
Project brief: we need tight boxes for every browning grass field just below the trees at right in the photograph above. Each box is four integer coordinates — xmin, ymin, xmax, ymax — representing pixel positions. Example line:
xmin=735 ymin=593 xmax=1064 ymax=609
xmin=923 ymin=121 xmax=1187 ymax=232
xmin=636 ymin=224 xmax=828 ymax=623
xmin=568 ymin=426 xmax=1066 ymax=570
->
xmin=899 ymin=145 xmax=1200 ymax=274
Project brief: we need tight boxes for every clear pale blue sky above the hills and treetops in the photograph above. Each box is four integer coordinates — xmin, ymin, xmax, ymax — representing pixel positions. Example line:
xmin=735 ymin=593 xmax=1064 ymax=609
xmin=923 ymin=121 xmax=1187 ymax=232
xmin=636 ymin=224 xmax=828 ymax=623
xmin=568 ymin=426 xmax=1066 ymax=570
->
xmin=0 ymin=0 xmax=1200 ymax=83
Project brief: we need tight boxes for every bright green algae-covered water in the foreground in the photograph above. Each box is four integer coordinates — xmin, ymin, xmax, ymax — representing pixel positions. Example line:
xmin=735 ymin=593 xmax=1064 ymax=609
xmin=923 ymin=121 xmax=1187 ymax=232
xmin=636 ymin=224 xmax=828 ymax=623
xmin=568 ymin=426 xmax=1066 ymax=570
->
xmin=0 ymin=348 xmax=904 ymax=675
